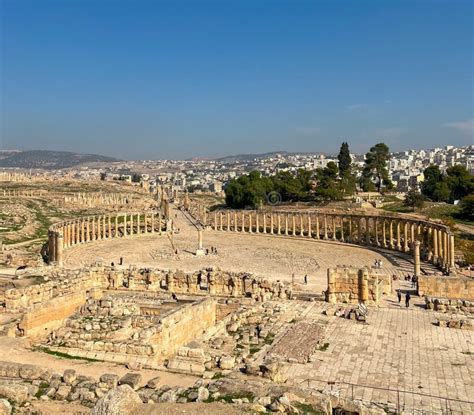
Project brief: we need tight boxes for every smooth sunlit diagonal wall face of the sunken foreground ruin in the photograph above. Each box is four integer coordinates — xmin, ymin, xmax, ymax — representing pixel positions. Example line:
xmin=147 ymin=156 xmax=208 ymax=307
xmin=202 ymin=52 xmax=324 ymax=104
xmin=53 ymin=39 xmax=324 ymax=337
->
xmin=154 ymin=298 xmax=216 ymax=358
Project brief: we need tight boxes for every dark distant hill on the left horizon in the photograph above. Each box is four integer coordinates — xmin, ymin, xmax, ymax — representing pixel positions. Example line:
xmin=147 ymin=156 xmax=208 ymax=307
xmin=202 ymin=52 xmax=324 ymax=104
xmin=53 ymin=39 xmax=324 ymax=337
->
xmin=0 ymin=150 xmax=120 ymax=170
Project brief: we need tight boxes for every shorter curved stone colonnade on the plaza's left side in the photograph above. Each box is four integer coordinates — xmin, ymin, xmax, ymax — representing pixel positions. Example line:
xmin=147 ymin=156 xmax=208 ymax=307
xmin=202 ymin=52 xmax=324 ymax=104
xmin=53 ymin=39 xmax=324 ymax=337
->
xmin=48 ymin=211 xmax=168 ymax=266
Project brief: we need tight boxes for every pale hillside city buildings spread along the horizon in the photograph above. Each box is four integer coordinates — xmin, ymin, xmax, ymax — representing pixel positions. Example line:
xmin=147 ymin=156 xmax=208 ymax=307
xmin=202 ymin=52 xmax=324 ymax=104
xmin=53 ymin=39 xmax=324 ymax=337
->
xmin=0 ymin=145 xmax=474 ymax=193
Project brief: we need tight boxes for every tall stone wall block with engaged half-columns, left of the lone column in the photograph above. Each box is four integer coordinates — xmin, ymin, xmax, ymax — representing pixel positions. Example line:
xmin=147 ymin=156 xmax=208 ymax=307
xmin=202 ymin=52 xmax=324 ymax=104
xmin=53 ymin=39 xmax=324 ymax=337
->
xmin=326 ymin=267 xmax=391 ymax=304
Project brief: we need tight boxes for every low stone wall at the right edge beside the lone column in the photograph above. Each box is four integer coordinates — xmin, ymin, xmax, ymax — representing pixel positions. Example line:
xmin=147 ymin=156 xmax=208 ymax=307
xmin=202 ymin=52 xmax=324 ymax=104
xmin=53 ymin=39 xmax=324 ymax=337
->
xmin=418 ymin=276 xmax=474 ymax=301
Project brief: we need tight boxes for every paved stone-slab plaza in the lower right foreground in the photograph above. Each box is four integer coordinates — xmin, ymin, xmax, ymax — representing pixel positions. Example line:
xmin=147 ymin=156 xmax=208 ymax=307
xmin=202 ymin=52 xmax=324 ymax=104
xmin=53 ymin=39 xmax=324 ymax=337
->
xmin=284 ymin=304 xmax=474 ymax=413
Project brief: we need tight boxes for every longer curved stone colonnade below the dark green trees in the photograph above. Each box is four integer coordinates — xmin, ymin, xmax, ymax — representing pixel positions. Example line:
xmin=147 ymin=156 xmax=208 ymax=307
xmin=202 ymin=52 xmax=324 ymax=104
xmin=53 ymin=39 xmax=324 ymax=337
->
xmin=196 ymin=208 xmax=454 ymax=272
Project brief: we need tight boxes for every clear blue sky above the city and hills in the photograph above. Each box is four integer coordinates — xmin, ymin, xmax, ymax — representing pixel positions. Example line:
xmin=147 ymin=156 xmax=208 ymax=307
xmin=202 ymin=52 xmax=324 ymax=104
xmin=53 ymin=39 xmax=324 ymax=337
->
xmin=0 ymin=0 xmax=474 ymax=159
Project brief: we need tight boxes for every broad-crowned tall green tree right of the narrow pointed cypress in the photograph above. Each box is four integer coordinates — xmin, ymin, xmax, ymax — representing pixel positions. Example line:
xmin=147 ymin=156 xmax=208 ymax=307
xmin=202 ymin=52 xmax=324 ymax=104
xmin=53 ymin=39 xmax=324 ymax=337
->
xmin=361 ymin=143 xmax=393 ymax=193
